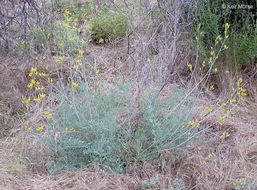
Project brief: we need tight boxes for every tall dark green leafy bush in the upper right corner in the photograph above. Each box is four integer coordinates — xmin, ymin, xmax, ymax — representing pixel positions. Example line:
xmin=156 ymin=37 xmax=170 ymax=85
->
xmin=196 ymin=0 xmax=257 ymax=68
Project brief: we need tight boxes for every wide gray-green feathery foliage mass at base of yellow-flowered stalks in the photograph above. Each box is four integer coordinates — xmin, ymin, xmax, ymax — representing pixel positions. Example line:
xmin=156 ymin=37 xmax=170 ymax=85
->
xmin=47 ymin=78 xmax=196 ymax=172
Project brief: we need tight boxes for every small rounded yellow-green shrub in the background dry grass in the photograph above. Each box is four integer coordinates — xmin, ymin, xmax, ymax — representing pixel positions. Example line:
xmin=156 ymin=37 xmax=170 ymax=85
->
xmin=91 ymin=11 xmax=127 ymax=43
